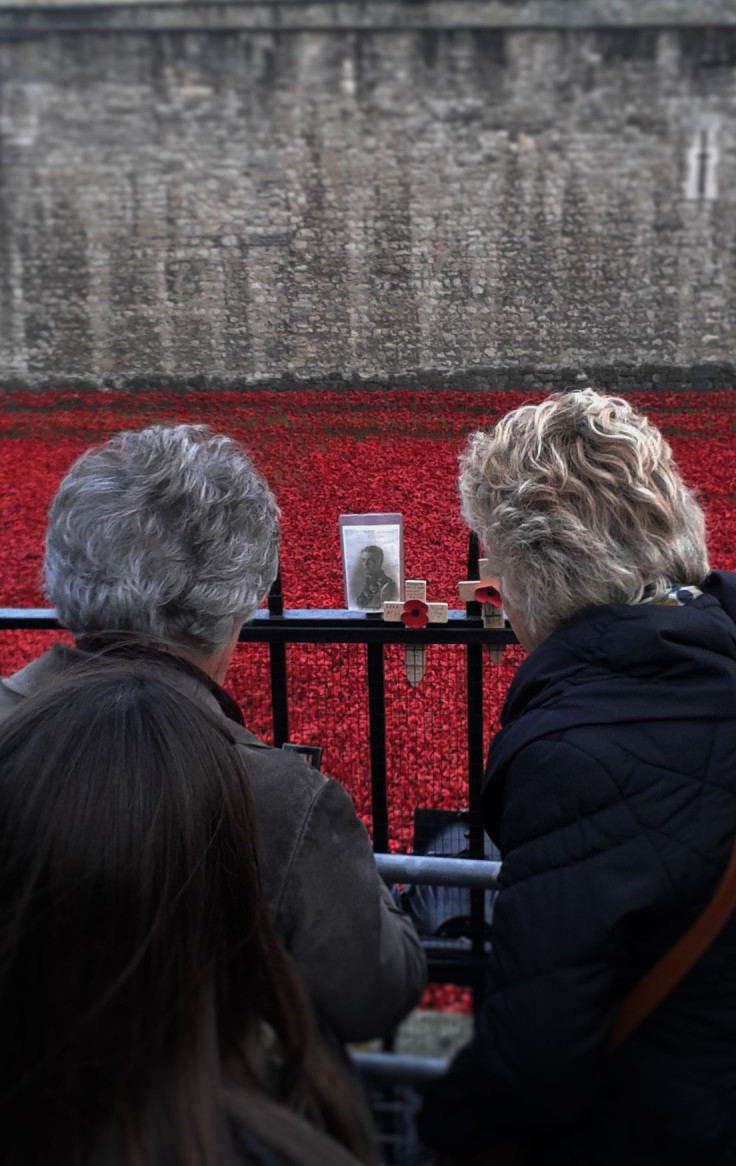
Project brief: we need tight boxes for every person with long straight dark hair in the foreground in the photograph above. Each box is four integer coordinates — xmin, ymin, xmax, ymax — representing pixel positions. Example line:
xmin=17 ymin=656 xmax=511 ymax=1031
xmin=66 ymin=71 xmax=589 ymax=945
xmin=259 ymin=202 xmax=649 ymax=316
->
xmin=0 ymin=662 xmax=374 ymax=1166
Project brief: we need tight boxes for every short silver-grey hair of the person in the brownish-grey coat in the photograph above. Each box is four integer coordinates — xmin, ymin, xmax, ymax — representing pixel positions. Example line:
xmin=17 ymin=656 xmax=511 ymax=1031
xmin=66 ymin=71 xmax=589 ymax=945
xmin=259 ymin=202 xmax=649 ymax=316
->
xmin=44 ymin=424 xmax=279 ymax=654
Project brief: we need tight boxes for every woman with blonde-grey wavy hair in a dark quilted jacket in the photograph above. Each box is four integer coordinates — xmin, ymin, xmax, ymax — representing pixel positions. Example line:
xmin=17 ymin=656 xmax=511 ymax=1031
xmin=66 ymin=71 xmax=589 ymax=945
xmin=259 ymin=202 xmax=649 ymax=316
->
xmin=419 ymin=389 xmax=736 ymax=1166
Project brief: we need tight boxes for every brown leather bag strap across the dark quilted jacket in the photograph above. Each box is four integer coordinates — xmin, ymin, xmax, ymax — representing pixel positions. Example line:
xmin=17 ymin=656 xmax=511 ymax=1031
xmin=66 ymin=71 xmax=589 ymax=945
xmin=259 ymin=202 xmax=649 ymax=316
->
xmin=608 ymin=841 xmax=736 ymax=1052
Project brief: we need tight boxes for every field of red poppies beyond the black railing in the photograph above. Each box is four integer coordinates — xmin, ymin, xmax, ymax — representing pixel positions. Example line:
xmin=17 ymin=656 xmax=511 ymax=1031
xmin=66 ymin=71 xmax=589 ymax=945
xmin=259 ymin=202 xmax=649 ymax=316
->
xmin=0 ymin=391 xmax=736 ymax=1006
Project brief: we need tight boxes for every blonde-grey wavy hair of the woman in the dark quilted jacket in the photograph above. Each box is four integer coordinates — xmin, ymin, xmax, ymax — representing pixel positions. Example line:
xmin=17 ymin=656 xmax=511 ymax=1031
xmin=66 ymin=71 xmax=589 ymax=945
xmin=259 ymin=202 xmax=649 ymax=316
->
xmin=460 ymin=388 xmax=708 ymax=638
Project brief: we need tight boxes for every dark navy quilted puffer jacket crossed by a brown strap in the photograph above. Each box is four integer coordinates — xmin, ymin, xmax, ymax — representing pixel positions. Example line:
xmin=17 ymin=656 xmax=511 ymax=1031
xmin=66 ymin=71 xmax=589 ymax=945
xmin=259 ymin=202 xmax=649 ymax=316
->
xmin=419 ymin=573 xmax=736 ymax=1166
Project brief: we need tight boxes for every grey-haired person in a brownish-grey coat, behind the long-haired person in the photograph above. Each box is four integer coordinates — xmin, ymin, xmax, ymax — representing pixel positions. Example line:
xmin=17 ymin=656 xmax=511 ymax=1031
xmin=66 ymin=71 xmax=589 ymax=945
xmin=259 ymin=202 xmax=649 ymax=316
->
xmin=0 ymin=424 xmax=425 ymax=1040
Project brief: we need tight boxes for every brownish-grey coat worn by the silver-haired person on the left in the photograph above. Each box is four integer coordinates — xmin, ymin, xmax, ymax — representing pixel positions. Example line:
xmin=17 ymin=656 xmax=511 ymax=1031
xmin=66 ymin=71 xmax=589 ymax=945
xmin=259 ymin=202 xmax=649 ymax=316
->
xmin=0 ymin=644 xmax=426 ymax=1041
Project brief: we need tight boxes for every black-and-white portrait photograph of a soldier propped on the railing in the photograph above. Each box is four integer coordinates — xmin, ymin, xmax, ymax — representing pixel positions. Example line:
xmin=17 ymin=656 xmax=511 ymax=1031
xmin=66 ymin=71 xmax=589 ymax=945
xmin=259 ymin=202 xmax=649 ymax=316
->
xmin=339 ymin=514 xmax=404 ymax=611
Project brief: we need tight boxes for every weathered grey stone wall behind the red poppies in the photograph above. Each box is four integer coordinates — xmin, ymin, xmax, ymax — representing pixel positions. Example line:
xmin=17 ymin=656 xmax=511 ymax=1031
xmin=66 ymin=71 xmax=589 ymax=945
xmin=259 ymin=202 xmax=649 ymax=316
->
xmin=0 ymin=3 xmax=736 ymax=387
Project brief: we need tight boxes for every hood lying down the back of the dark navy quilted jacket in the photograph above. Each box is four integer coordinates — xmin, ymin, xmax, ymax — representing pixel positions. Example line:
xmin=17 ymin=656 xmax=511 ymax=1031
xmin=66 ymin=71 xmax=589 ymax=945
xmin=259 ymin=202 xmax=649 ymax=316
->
xmin=482 ymin=573 xmax=736 ymax=838
